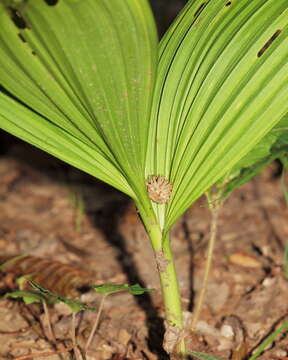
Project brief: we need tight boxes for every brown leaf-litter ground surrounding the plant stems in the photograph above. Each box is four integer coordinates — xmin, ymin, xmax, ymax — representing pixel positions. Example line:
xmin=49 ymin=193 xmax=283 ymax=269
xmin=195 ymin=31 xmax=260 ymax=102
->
xmin=0 ymin=142 xmax=288 ymax=360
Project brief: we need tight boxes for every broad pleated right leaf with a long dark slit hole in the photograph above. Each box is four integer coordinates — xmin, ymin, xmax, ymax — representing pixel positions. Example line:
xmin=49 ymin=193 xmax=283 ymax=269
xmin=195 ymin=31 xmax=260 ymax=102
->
xmin=146 ymin=0 xmax=288 ymax=229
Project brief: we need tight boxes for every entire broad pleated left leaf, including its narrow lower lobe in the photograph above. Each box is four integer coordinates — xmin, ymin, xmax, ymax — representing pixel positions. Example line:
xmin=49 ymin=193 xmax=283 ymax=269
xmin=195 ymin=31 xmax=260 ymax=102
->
xmin=0 ymin=0 xmax=157 ymax=198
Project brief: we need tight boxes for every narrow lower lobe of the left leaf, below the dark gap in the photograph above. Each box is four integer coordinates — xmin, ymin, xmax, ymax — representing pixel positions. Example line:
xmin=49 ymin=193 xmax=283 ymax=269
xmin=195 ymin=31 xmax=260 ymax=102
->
xmin=0 ymin=92 xmax=134 ymax=197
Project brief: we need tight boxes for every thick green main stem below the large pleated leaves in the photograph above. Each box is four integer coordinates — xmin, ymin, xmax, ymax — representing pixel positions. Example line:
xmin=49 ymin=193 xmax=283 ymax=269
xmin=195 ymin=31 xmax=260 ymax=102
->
xmin=139 ymin=202 xmax=186 ymax=356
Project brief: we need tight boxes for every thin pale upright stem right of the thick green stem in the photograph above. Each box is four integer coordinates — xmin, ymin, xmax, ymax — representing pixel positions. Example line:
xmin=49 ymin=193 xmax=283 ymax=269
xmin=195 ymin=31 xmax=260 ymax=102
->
xmin=191 ymin=205 xmax=219 ymax=331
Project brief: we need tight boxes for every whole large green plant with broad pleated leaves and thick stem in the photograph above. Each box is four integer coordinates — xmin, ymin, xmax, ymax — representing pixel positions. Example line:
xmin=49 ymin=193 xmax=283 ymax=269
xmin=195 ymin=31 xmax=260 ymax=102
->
xmin=0 ymin=0 xmax=288 ymax=355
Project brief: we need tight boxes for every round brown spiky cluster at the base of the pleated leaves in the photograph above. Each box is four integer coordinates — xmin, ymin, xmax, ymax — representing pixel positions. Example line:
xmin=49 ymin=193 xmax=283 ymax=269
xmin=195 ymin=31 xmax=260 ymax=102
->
xmin=146 ymin=175 xmax=173 ymax=204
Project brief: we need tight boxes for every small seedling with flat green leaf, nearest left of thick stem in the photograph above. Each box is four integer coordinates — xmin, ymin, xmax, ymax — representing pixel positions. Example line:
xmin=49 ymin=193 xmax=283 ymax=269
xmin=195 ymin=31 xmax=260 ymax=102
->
xmin=85 ymin=284 xmax=155 ymax=351
